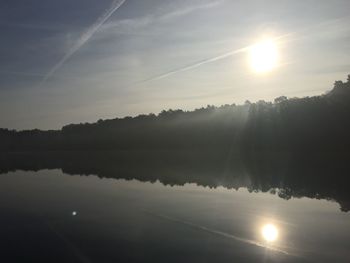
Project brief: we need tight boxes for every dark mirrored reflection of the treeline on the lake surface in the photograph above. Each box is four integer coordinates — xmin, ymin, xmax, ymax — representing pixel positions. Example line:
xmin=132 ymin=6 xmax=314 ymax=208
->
xmin=0 ymin=150 xmax=350 ymax=211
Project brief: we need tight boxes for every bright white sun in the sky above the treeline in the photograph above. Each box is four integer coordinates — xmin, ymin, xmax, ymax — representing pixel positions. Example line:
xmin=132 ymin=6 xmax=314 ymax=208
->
xmin=249 ymin=39 xmax=278 ymax=73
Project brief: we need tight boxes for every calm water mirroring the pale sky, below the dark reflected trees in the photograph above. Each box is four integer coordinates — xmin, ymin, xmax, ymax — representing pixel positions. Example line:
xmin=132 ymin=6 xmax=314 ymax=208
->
xmin=0 ymin=169 xmax=350 ymax=262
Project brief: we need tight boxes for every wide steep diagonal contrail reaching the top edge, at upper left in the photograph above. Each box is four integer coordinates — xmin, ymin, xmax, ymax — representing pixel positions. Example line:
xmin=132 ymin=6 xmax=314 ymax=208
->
xmin=41 ymin=0 xmax=126 ymax=85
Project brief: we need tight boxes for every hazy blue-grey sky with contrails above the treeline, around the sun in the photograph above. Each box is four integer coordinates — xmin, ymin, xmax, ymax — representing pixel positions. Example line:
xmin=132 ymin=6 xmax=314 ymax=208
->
xmin=0 ymin=0 xmax=350 ymax=130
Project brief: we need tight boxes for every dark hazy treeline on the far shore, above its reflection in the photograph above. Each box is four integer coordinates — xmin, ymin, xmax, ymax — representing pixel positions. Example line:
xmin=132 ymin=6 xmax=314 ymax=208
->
xmin=0 ymin=74 xmax=350 ymax=153
